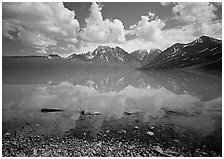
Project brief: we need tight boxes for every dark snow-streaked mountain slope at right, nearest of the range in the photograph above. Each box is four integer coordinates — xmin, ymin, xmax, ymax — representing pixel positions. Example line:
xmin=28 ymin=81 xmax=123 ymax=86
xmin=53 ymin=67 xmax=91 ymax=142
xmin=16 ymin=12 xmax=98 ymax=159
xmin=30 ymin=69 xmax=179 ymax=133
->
xmin=143 ymin=36 xmax=222 ymax=69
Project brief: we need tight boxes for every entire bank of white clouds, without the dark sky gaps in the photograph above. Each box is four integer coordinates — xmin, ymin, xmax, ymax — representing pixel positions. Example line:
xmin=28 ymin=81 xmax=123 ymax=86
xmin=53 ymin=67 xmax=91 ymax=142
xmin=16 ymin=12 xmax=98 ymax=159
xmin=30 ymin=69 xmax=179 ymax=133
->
xmin=2 ymin=2 xmax=222 ymax=54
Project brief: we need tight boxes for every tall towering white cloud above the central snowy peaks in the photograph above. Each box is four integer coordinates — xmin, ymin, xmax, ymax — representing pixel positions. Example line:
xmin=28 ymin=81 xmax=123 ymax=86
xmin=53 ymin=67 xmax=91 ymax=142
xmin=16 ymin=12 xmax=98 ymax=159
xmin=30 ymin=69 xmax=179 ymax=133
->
xmin=80 ymin=2 xmax=126 ymax=43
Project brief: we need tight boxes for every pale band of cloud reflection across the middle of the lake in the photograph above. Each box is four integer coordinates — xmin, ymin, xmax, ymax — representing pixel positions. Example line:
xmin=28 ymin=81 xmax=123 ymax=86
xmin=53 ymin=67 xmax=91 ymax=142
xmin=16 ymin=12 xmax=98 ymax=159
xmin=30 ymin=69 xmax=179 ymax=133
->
xmin=30 ymin=82 xmax=219 ymax=118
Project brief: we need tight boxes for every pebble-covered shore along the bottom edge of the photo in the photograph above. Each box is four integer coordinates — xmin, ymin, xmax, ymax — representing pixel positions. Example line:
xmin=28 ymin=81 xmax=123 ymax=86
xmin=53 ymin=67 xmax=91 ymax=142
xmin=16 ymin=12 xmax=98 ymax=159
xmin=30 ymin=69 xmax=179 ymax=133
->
xmin=2 ymin=123 xmax=221 ymax=157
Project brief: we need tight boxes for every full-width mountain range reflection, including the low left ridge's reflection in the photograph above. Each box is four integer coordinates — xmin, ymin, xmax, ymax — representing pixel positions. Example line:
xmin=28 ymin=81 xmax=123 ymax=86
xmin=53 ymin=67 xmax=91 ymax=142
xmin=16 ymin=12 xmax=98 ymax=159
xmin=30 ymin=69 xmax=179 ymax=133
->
xmin=3 ymin=70 xmax=222 ymax=101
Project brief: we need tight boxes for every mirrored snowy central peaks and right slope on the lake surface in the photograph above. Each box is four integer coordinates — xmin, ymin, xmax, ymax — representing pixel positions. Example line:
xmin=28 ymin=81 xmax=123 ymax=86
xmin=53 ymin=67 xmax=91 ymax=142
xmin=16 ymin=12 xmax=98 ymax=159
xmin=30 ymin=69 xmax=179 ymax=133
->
xmin=70 ymin=71 xmax=222 ymax=101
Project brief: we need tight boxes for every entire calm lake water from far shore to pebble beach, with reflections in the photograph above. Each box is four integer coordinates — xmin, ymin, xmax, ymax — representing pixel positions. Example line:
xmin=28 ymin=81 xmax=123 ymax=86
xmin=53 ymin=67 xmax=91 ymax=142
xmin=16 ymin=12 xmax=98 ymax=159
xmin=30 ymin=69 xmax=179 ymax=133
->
xmin=2 ymin=69 xmax=222 ymax=154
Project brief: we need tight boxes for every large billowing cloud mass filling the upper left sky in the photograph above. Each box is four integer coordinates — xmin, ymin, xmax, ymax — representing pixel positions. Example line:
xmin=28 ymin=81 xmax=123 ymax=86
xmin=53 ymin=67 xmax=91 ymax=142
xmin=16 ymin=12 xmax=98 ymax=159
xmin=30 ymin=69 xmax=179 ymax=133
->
xmin=2 ymin=2 xmax=79 ymax=53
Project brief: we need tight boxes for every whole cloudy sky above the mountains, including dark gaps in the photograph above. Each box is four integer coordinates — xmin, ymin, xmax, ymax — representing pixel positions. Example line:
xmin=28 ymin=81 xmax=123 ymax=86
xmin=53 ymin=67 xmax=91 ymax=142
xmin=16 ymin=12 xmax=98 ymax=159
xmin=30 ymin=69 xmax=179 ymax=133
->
xmin=2 ymin=2 xmax=222 ymax=57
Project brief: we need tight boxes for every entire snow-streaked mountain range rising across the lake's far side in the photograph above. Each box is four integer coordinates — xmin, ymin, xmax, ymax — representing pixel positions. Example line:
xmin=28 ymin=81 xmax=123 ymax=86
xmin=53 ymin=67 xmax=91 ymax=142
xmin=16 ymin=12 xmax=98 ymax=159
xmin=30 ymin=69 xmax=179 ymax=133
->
xmin=3 ymin=36 xmax=222 ymax=69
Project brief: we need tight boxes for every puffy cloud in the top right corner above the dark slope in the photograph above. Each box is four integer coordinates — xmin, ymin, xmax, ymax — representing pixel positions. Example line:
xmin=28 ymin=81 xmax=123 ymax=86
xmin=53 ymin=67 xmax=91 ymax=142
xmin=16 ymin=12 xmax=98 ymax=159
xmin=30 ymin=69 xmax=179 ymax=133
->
xmin=172 ymin=2 xmax=222 ymax=38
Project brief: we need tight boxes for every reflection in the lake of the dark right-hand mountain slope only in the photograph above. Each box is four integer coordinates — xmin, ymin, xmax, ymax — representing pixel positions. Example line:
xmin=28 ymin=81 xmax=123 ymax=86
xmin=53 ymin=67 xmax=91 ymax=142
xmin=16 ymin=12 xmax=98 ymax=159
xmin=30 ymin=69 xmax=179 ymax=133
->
xmin=143 ymin=71 xmax=222 ymax=101
